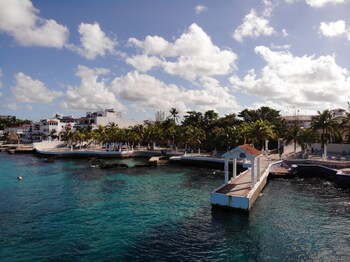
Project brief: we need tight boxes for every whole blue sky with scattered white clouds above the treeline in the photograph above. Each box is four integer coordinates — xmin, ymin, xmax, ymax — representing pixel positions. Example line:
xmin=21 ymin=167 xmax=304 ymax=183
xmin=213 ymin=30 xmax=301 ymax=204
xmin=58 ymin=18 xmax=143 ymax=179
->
xmin=0 ymin=0 xmax=350 ymax=120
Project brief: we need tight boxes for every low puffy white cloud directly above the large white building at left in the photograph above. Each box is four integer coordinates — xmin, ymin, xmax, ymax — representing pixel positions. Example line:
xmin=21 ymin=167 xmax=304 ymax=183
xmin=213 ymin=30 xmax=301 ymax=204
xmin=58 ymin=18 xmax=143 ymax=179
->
xmin=62 ymin=65 xmax=124 ymax=111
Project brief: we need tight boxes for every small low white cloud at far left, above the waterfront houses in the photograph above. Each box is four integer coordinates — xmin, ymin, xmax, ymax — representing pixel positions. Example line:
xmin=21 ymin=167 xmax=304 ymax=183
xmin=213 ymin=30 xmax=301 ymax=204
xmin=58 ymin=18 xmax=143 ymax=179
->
xmin=11 ymin=72 xmax=63 ymax=104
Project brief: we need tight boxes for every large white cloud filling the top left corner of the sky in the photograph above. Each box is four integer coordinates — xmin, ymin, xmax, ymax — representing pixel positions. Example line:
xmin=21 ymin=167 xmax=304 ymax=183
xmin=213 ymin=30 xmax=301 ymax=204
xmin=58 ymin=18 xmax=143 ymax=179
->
xmin=0 ymin=0 xmax=69 ymax=48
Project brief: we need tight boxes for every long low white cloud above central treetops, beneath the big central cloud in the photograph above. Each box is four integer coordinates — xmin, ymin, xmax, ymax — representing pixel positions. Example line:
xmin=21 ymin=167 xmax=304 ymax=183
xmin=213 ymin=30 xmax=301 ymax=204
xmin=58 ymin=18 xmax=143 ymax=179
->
xmin=112 ymin=71 xmax=238 ymax=112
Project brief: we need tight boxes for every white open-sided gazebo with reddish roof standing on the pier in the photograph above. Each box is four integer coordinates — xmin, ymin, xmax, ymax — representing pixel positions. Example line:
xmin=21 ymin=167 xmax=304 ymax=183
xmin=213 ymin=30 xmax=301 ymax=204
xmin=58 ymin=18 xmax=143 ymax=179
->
xmin=222 ymin=144 xmax=262 ymax=188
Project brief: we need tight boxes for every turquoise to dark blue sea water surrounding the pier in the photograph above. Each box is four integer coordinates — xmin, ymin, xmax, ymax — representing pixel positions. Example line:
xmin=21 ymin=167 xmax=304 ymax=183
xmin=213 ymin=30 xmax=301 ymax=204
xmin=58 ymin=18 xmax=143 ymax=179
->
xmin=0 ymin=153 xmax=350 ymax=261
